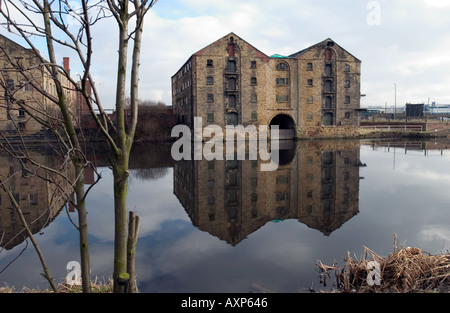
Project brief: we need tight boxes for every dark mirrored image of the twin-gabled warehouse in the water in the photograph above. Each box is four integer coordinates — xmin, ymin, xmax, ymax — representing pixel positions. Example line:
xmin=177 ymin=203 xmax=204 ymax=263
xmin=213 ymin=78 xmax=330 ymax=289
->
xmin=173 ymin=140 xmax=362 ymax=245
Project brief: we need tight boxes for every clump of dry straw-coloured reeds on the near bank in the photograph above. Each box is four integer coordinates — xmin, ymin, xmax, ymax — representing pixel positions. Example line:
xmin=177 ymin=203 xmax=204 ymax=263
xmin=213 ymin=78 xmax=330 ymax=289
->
xmin=317 ymin=238 xmax=450 ymax=293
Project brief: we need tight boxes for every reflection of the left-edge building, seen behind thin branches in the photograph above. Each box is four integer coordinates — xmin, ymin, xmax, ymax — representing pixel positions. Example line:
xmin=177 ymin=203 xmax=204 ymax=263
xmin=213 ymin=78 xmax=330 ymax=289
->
xmin=0 ymin=150 xmax=72 ymax=251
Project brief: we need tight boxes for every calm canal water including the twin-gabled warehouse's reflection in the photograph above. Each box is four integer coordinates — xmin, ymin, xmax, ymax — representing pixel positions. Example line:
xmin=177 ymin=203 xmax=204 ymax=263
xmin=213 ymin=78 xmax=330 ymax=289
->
xmin=0 ymin=140 xmax=450 ymax=292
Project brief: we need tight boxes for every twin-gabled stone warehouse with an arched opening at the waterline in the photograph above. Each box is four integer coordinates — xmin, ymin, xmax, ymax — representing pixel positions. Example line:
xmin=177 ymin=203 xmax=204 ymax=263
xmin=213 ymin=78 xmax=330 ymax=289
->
xmin=172 ymin=33 xmax=361 ymax=137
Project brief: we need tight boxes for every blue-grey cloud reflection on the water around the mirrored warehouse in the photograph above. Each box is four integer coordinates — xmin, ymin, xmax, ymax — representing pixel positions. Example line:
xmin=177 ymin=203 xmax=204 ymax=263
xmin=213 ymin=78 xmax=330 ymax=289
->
xmin=0 ymin=140 xmax=450 ymax=292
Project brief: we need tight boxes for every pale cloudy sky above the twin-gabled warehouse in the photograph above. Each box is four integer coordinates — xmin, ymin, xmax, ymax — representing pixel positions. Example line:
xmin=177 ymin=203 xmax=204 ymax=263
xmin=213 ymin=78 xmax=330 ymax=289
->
xmin=2 ymin=0 xmax=450 ymax=108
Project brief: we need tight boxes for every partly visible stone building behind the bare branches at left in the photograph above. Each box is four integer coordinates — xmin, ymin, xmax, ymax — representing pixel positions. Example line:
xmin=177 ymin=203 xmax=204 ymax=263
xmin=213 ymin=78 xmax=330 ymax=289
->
xmin=0 ymin=35 xmax=78 ymax=135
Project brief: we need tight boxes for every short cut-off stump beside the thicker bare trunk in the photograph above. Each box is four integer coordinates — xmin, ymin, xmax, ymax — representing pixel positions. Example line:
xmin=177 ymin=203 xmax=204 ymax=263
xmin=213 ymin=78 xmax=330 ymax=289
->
xmin=127 ymin=211 xmax=140 ymax=293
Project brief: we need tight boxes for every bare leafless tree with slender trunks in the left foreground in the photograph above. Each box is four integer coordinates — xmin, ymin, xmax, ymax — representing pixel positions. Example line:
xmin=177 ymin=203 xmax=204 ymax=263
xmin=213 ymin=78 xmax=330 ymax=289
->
xmin=0 ymin=0 xmax=157 ymax=292
